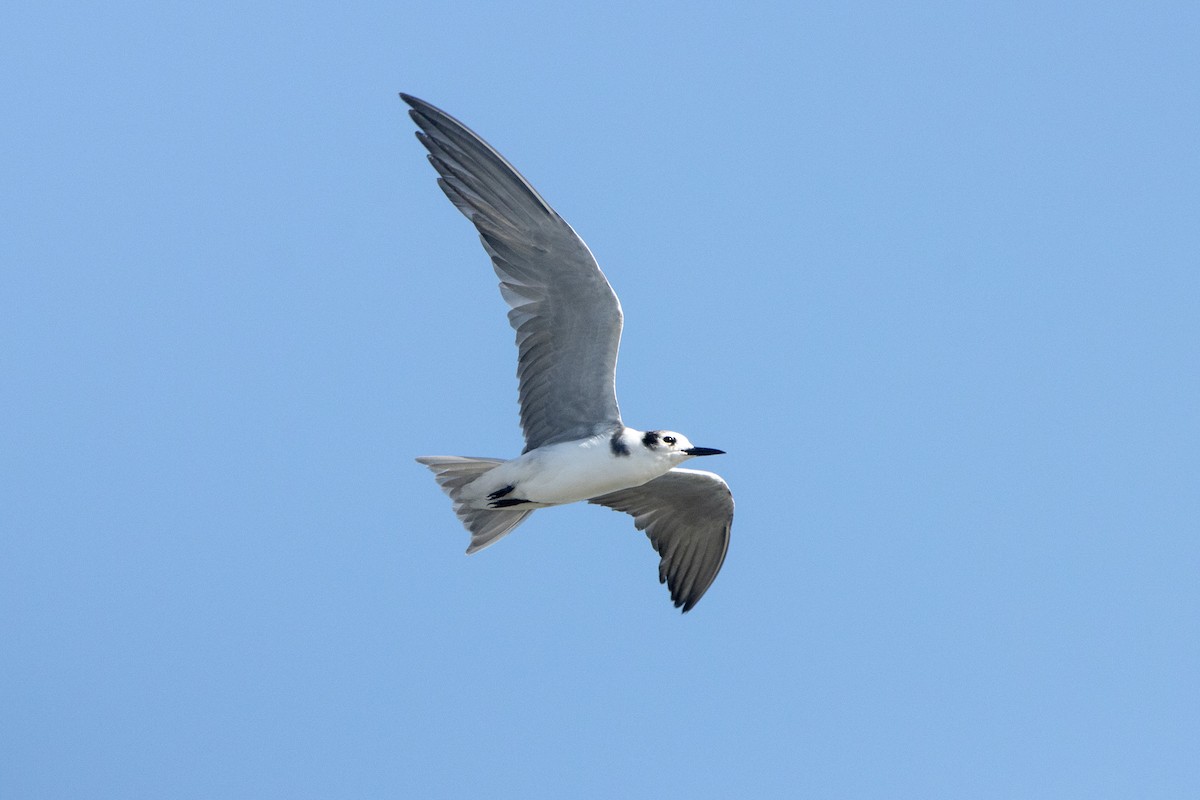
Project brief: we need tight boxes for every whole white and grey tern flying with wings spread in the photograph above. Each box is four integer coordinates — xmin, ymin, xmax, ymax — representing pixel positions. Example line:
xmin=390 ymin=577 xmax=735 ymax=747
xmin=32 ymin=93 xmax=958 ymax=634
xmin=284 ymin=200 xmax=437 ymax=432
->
xmin=401 ymin=94 xmax=733 ymax=612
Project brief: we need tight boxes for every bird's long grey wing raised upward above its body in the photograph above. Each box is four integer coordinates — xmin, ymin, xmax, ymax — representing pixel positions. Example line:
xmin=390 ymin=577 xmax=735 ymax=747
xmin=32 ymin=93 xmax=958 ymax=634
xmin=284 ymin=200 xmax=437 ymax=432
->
xmin=401 ymin=94 xmax=622 ymax=451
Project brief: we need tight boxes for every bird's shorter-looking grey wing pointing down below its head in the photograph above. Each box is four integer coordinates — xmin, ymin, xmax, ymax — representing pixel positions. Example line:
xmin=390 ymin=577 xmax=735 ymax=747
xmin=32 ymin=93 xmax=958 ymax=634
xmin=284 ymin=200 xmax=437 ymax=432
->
xmin=588 ymin=467 xmax=733 ymax=612
